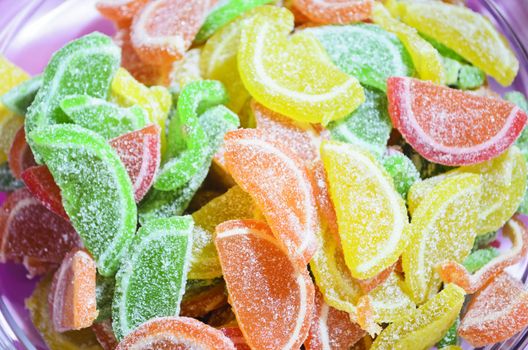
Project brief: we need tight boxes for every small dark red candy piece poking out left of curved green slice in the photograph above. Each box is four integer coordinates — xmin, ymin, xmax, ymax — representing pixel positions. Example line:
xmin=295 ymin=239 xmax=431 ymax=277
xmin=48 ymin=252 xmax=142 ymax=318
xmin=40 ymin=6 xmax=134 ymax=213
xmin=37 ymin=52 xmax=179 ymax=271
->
xmin=22 ymin=165 xmax=69 ymax=220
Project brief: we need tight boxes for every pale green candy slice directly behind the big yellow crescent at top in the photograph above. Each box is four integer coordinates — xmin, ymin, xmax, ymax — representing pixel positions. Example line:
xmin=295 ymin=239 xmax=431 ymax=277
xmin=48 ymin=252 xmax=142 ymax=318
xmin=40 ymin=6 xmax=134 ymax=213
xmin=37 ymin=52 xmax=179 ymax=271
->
xmin=305 ymin=24 xmax=414 ymax=91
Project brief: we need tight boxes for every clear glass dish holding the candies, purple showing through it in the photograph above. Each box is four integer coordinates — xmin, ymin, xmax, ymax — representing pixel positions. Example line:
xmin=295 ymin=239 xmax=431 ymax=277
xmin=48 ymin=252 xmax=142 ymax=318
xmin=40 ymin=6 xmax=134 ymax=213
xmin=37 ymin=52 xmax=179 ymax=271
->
xmin=0 ymin=0 xmax=528 ymax=350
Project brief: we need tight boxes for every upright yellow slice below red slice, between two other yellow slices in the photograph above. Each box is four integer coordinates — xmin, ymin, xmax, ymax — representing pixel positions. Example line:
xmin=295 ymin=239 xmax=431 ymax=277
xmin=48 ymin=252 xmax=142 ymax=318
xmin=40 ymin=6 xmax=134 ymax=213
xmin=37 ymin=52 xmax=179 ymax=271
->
xmin=402 ymin=174 xmax=482 ymax=304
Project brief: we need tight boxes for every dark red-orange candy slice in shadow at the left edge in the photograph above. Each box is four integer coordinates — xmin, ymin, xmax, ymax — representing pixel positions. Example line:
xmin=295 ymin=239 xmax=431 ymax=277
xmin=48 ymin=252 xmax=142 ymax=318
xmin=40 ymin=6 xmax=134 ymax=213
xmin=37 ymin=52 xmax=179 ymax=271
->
xmin=0 ymin=188 xmax=80 ymax=274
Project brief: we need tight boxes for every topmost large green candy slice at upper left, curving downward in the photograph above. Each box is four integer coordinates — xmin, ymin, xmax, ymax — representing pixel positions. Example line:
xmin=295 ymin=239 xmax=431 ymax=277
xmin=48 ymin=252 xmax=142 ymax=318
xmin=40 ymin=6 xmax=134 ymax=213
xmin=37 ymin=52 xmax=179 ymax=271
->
xmin=25 ymin=33 xmax=120 ymax=156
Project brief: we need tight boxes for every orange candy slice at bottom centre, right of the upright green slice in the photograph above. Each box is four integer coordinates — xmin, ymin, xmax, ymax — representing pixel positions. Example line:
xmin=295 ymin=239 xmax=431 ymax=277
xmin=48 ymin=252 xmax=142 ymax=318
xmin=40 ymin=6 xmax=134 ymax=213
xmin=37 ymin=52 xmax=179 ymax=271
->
xmin=215 ymin=220 xmax=315 ymax=349
